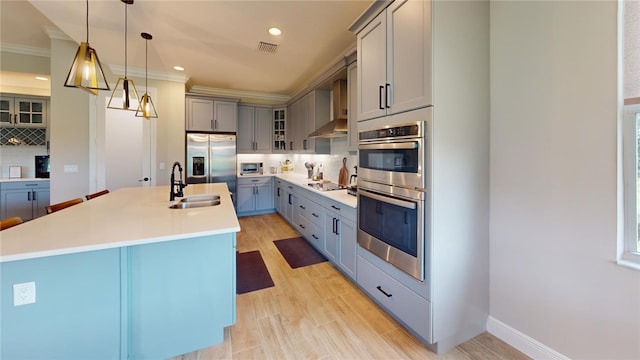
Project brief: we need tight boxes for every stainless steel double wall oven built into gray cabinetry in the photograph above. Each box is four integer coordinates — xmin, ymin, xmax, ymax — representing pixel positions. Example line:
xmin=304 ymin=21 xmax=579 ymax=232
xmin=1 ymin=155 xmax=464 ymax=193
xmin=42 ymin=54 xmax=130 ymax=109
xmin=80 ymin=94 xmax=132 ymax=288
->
xmin=357 ymin=112 xmax=430 ymax=281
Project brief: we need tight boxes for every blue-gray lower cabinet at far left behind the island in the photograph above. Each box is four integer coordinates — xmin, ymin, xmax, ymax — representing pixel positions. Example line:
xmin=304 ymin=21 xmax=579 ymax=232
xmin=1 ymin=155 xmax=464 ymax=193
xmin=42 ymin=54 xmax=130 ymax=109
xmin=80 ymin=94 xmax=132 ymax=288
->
xmin=0 ymin=180 xmax=50 ymax=221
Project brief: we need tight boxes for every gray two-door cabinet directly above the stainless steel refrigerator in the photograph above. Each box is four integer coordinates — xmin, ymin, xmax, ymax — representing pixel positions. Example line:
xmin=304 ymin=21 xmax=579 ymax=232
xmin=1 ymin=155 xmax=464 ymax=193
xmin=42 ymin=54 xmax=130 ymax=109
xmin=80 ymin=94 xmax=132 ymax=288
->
xmin=186 ymin=96 xmax=238 ymax=132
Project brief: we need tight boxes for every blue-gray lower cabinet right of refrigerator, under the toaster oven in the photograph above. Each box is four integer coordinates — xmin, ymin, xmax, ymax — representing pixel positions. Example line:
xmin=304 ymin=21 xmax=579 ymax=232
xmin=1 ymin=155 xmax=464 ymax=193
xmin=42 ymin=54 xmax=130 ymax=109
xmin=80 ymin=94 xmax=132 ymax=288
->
xmin=236 ymin=176 xmax=273 ymax=215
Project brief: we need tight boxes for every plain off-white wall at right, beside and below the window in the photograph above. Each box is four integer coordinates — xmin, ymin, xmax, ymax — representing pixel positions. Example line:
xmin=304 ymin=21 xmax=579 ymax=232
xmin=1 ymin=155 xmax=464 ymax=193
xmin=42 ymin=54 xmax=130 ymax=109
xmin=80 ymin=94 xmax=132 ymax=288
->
xmin=490 ymin=1 xmax=640 ymax=359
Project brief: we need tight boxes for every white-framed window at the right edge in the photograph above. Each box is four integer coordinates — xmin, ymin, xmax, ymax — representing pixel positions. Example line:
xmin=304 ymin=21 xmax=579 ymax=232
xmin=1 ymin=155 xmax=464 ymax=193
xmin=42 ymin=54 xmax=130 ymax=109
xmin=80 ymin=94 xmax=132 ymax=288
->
xmin=618 ymin=1 xmax=640 ymax=269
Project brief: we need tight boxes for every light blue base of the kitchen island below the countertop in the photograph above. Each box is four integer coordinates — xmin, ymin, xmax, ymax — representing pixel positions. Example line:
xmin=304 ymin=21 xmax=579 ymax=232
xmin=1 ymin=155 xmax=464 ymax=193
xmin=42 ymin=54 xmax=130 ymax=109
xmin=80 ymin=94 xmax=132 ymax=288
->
xmin=0 ymin=233 xmax=236 ymax=359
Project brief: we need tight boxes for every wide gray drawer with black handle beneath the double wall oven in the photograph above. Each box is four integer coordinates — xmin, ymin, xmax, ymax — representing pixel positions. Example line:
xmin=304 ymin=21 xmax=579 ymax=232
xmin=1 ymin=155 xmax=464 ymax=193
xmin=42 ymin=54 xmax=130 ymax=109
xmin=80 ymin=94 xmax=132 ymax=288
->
xmin=356 ymin=256 xmax=433 ymax=343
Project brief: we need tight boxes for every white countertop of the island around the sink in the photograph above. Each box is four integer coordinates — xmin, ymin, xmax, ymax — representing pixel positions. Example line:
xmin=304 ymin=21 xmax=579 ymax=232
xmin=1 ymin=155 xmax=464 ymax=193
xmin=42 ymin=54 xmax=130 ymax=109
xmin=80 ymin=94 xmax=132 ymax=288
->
xmin=0 ymin=183 xmax=240 ymax=262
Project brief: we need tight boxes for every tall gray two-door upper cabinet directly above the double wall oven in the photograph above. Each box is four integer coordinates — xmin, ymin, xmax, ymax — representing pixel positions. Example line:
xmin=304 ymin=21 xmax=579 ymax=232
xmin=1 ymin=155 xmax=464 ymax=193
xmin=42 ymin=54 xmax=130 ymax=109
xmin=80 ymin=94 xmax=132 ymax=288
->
xmin=357 ymin=0 xmax=432 ymax=121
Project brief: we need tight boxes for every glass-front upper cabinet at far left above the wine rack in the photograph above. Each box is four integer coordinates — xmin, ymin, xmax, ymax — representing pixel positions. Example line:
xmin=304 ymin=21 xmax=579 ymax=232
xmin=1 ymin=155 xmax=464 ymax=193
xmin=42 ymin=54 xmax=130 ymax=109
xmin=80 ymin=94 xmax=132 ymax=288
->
xmin=0 ymin=95 xmax=48 ymax=128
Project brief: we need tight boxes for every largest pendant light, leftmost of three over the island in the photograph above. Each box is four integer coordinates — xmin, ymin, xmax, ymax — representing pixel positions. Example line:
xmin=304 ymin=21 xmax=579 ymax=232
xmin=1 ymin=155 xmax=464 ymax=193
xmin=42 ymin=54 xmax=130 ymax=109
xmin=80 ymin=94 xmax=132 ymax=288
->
xmin=64 ymin=0 xmax=110 ymax=95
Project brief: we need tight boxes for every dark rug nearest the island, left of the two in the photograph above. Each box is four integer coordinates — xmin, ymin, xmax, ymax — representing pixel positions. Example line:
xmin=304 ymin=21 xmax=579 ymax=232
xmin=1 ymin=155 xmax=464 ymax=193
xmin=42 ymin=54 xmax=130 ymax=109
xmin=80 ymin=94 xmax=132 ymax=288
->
xmin=236 ymin=250 xmax=274 ymax=294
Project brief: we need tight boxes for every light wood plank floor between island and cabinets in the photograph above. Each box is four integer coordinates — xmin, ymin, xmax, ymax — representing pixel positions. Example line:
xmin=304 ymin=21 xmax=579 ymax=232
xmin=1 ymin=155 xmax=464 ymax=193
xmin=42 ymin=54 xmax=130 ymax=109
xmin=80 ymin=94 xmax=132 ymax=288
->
xmin=174 ymin=214 xmax=528 ymax=360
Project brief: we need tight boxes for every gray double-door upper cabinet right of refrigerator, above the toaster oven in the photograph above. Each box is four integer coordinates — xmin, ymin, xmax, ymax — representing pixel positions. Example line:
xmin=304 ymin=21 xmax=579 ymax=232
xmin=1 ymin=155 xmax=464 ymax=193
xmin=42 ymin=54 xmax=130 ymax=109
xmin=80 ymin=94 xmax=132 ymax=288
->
xmin=238 ymin=105 xmax=273 ymax=154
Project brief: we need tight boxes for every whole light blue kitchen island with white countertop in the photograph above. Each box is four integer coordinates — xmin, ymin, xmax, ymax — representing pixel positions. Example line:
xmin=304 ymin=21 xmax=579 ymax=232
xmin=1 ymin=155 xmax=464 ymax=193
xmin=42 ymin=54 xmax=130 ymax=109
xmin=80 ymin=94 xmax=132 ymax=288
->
xmin=0 ymin=184 xmax=240 ymax=359
